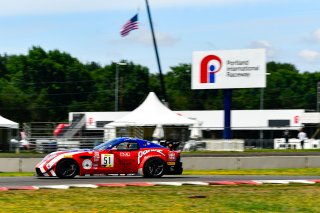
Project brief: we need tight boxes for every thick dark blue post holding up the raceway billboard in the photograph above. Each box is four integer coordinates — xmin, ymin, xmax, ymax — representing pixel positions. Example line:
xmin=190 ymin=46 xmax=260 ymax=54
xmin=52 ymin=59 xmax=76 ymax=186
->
xmin=223 ymin=89 xmax=232 ymax=139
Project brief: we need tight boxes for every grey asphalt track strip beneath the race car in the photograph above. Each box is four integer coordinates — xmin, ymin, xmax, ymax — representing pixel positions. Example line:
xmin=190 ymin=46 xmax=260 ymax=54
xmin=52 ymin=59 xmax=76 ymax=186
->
xmin=0 ymin=175 xmax=320 ymax=187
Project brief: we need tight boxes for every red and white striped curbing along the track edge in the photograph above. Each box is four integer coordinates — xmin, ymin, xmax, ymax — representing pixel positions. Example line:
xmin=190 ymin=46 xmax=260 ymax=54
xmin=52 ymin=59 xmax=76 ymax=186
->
xmin=0 ymin=180 xmax=320 ymax=191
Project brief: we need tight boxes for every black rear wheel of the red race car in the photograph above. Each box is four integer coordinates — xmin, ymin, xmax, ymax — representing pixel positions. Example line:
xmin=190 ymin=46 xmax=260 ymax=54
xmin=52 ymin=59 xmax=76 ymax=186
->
xmin=143 ymin=158 xmax=165 ymax=178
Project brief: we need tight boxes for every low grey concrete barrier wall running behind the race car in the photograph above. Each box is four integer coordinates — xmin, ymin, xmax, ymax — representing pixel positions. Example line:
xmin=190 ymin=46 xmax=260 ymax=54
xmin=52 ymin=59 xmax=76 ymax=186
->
xmin=0 ymin=156 xmax=320 ymax=172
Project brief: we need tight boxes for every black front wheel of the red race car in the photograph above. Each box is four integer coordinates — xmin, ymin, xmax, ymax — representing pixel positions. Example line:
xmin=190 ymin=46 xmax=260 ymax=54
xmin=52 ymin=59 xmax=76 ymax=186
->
xmin=56 ymin=159 xmax=79 ymax=179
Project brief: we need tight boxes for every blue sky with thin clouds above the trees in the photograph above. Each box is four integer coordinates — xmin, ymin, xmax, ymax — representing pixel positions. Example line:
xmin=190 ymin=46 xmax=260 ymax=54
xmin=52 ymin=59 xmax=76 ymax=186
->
xmin=0 ymin=0 xmax=320 ymax=73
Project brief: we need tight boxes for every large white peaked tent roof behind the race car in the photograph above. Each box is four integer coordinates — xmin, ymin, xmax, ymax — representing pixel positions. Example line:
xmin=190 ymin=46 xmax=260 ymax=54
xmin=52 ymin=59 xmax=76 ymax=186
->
xmin=107 ymin=92 xmax=195 ymax=127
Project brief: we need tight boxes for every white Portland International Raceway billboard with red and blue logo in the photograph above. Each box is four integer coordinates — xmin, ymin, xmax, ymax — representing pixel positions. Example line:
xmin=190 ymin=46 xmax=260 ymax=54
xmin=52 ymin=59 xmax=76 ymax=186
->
xmin=191 ymin=49 xmax=266 ymax=89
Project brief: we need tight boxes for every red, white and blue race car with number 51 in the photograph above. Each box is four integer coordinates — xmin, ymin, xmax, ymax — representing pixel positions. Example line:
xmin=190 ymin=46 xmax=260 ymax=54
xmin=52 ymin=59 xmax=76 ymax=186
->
xmin=36 ymin=137 xmax=183 ymax=178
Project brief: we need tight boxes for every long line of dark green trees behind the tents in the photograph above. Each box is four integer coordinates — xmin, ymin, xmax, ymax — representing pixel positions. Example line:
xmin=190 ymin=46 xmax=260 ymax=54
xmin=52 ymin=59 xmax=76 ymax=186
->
xmin=0 ymin=47 xmax=320 ymax=123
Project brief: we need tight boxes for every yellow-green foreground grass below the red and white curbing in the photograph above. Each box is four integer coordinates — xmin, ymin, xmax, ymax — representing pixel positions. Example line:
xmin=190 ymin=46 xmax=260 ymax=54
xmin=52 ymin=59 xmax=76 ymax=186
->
xmin=0 ymin=185 xmax=320 ymax=213
